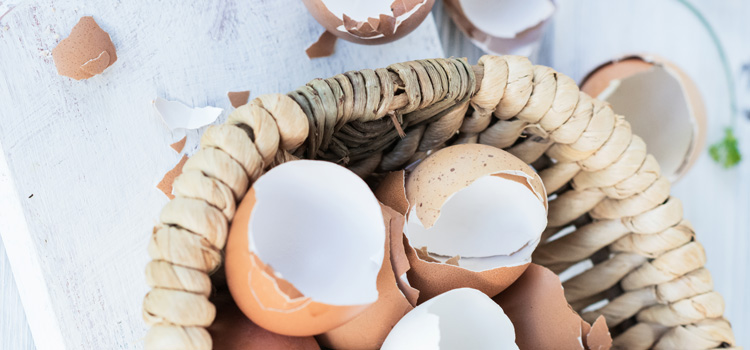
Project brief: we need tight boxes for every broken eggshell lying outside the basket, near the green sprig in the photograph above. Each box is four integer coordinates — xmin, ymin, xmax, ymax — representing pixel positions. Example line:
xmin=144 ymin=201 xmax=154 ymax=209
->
xmin=581 ymin=55 xmax=707 ymax=182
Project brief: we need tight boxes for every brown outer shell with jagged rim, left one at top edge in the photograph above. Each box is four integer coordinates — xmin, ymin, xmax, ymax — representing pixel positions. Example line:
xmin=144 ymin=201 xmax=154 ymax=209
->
xmin=302 ymin=0 xmax=435 ymax=45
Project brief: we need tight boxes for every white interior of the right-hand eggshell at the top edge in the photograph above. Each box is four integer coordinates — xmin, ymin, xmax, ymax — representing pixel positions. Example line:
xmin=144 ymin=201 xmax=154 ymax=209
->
xmin=459 ymin=0 xmax=555 ymax=38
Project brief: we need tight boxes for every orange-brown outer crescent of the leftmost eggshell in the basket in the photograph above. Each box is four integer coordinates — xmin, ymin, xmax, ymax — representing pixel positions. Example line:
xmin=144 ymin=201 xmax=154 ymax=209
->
xmin=225 ymin=188 xmax=369 ymax=336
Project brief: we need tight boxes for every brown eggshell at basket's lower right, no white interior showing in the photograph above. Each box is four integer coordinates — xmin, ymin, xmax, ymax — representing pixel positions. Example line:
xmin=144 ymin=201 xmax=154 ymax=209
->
xmin=492 ymin=264 xmax=612 ymax=350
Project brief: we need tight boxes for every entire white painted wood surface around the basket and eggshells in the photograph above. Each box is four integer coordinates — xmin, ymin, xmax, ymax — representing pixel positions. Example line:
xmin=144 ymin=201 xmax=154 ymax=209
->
xmin=0 ymin=0 xmax=750 ymax=349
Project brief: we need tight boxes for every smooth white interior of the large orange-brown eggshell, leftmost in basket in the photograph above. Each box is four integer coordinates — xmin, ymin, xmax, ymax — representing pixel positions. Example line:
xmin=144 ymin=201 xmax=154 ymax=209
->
xmin=248 ymin=160 xmax=385 ymax=305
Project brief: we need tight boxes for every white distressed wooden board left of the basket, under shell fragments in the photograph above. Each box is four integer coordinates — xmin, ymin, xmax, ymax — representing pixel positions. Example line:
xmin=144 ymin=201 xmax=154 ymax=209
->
xmin=0 ymin=0 xmax=442 ymax=349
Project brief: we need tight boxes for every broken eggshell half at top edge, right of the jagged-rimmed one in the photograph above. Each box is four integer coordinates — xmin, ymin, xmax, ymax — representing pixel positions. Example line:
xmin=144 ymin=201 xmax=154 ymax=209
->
xmin=444 ymin=0 xmax=555 ymax=56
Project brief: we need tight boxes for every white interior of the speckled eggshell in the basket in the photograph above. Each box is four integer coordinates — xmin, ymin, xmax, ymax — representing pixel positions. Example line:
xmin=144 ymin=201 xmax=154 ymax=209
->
xmin=405 ymin=175 xmax=547 ymax=271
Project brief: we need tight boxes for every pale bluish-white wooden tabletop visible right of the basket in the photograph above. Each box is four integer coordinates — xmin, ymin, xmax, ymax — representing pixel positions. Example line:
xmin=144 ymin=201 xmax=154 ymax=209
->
xmin=434 ymin=0 xmax=750 ymax=346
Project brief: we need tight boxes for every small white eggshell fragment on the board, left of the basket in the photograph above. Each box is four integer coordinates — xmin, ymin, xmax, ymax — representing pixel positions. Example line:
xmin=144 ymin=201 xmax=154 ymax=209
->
xmin=154 ymin=97 xmax=224 ymax=130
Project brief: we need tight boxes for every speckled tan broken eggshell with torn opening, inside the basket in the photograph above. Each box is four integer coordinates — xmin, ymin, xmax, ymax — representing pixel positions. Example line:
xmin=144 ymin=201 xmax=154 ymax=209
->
xmin=376 ymin=144 xmax=547 ymax=303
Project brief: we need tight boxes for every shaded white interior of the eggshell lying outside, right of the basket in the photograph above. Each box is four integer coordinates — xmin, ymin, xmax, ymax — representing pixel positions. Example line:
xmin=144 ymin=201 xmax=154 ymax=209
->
xmin=598 ymin=65 xmax=696 ymax=176
